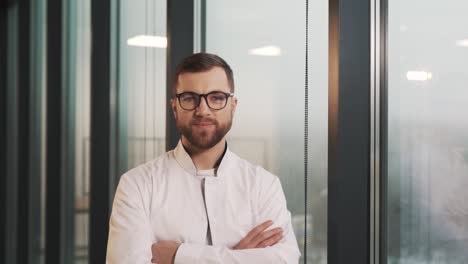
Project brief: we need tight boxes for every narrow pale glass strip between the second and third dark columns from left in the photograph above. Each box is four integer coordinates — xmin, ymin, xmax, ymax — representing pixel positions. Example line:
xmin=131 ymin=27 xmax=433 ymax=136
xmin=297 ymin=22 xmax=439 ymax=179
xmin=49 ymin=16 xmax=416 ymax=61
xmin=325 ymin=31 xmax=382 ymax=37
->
xmin=65 ymin=0 xmax=91 ymax=263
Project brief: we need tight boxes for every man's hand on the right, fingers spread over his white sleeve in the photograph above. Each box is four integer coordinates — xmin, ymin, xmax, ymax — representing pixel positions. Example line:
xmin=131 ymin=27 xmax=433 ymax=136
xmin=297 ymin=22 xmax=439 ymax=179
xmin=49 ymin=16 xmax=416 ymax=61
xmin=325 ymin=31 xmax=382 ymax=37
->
xmin=234 ymin=220 xmax=283 ymax=249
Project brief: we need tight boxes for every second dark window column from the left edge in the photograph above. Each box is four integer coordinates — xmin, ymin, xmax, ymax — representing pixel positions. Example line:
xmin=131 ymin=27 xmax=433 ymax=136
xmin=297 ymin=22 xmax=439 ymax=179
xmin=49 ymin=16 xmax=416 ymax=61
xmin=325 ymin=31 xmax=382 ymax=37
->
xmin=45 ymin=0 xmax=66 ymax=264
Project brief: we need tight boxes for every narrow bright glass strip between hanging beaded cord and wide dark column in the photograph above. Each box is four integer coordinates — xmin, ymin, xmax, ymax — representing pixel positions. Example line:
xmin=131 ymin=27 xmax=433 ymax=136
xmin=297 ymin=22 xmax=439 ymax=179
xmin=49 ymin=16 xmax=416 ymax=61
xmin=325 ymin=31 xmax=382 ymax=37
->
xmin=308 ymin=0 xmax=329 ymax=264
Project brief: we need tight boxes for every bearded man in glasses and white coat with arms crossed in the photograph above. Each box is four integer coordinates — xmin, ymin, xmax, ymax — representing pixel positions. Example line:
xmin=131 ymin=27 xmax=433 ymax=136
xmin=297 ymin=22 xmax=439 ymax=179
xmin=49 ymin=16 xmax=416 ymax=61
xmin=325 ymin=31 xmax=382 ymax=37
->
xmin=107 ymin=53 xmax=300 ymax=264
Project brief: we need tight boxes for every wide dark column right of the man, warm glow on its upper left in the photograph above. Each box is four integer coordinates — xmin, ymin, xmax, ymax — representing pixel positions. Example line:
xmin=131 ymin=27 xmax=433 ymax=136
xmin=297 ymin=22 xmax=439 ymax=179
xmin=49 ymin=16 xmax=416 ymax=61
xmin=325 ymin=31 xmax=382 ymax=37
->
xmin=328 ymin=0 xmax=371 ymax=264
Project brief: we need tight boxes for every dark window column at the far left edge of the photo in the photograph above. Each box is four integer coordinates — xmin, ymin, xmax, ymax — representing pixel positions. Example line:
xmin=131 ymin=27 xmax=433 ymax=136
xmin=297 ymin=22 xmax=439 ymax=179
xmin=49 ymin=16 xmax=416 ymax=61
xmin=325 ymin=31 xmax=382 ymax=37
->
xmin=0 ymin=1 xmax=29 ymax=263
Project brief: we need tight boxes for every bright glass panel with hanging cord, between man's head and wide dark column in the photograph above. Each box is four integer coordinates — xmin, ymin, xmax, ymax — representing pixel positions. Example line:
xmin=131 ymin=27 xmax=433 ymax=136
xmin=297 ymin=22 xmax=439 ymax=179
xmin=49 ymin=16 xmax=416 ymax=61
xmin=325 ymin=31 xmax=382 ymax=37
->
xmin=206 ymin=0 xmax=328 ymax=263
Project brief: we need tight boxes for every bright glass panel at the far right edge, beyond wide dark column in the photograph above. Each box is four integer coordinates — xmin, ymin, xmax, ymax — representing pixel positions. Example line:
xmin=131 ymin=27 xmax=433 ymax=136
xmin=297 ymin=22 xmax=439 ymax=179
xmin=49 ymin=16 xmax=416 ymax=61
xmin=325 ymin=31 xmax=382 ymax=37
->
xmin=387 ymin=0 xmax=468 ymax=264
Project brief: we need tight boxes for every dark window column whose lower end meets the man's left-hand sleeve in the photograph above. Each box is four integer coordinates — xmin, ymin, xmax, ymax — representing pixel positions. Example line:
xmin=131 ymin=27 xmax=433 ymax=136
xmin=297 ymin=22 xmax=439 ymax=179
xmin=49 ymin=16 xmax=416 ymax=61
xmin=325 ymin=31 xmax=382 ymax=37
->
xmin=89 ymin=0 xmax=116 ymax=264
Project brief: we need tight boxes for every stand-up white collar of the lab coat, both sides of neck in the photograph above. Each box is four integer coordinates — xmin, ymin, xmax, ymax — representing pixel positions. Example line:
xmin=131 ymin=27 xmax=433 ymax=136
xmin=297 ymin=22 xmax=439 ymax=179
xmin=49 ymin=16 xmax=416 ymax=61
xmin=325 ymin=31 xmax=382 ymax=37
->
xmin=174 ymin=140 xmax=233 ymax=179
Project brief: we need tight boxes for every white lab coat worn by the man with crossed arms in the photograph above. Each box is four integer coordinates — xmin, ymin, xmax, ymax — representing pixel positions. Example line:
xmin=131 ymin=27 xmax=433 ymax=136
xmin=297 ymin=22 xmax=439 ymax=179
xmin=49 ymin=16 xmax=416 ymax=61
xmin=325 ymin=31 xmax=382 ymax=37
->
xmin=107 ymin=142 xmax=300 ymax=264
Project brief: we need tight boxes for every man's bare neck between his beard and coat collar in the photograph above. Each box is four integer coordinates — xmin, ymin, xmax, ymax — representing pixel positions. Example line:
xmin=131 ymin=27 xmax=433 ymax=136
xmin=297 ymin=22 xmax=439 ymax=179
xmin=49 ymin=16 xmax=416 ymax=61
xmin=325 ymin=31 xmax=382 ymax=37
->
xmin=182 ymin=137 xmax=226 ymax=170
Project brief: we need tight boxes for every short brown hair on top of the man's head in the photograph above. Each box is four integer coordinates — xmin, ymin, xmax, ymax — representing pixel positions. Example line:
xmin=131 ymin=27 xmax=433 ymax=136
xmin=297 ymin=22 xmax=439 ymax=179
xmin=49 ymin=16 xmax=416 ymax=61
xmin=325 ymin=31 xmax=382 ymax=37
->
xmin=173 ymin=52 xmax=234 ymax=94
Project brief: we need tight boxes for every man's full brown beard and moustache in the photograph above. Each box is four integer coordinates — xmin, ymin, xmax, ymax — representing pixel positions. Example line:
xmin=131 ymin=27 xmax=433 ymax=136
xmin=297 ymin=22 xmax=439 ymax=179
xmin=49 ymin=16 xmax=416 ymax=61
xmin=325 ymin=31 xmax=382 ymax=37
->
xmin=176 ymin=117 xmax=232 ymax=150
